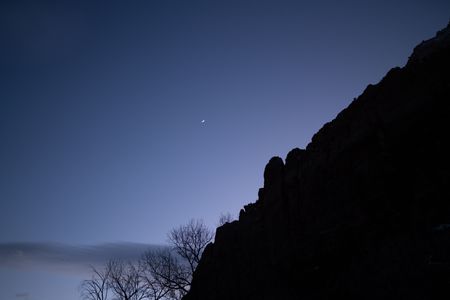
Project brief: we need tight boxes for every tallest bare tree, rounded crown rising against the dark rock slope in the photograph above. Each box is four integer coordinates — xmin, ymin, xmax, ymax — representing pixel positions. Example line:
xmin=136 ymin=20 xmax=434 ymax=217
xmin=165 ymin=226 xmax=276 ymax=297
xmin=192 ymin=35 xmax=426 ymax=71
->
xmin=169 ymin=219 xmax=214 ymax=275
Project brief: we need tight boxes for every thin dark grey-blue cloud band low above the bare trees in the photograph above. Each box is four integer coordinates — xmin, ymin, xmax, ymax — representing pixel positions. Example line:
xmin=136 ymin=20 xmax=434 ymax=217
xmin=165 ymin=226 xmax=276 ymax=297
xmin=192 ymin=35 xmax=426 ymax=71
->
xmin=0 ymin=243 xmax=165 ymax=273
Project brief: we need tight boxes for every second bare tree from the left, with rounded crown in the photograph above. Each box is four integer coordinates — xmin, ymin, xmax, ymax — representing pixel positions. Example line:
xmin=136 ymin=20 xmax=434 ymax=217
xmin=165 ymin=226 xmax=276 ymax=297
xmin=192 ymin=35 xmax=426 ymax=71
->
xmin=107 ymin=260 xmax=147 ymax=300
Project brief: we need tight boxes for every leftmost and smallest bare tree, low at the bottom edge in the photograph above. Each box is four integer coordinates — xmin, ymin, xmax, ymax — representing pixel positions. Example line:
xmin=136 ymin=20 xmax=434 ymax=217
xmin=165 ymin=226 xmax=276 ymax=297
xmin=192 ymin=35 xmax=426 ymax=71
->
xmin=80 ymin=266 xmax=109 ymax=300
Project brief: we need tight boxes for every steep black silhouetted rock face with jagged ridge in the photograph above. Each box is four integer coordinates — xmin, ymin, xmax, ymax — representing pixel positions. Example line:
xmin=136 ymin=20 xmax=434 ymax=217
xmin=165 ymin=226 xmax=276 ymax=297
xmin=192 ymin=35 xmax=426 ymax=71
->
xmin=184 ymin=26 xmax=450 ymax=300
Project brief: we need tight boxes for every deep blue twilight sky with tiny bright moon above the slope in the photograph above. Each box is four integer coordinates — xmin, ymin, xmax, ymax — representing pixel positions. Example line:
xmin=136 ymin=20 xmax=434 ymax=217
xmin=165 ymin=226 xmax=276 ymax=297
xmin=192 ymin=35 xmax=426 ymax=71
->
xmin=0 ymin=0 xmax=450 ymax=300
